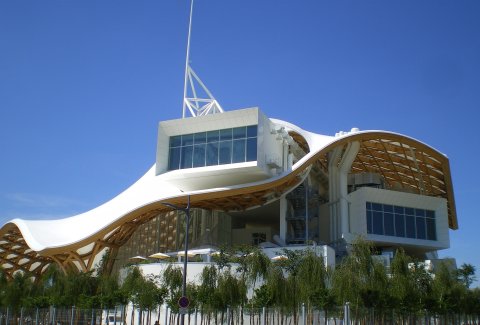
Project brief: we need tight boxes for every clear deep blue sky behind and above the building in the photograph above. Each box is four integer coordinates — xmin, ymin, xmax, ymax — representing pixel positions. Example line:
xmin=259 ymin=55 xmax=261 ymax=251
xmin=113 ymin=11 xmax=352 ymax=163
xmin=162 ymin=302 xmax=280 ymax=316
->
xmin=0 ymin=0 xmax=480 ymax=282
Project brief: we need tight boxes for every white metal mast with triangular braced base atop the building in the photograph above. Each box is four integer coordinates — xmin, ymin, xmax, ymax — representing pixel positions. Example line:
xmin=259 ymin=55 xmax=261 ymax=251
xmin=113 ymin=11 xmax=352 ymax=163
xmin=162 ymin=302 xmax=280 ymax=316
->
xmin=182 ymin=0 xmax=223 ymax=118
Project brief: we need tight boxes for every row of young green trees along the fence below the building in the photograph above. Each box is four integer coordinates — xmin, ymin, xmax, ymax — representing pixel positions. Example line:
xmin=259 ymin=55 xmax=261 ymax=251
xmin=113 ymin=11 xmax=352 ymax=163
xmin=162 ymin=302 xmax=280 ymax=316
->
xmin=0 ymin=240 xmax=480 ymax=324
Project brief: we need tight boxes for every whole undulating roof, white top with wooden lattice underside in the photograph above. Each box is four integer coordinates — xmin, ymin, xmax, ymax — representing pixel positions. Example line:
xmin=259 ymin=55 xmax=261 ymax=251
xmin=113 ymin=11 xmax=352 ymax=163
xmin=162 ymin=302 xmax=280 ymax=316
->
xmin=0 ymin=119 xmax=458 ymax=276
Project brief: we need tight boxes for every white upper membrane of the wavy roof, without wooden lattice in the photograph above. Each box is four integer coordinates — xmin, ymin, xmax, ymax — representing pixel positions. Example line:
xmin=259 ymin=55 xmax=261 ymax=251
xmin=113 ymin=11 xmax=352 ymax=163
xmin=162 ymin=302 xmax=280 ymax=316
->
xmin=0 ymin=119 xmax=458 ymax=252
